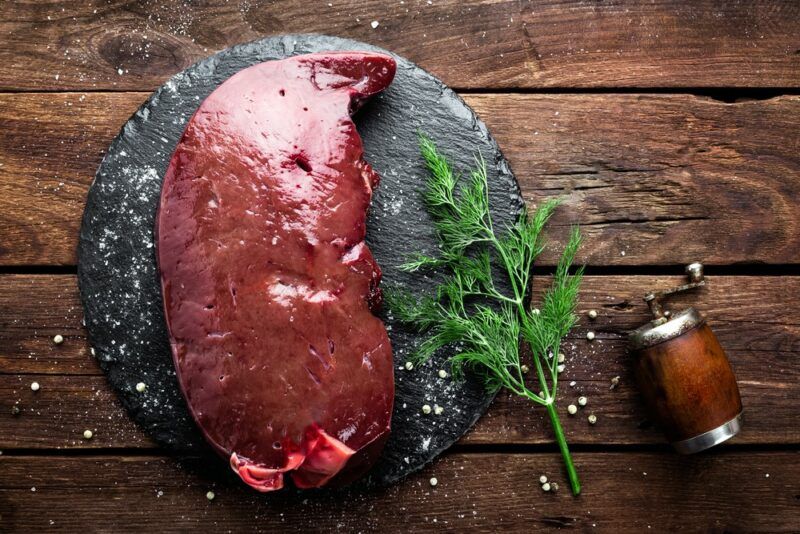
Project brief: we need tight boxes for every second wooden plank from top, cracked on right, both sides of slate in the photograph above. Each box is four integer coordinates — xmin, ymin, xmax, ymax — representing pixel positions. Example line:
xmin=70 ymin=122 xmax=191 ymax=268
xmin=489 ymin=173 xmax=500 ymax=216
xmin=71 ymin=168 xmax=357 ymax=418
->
xmin=0 ymin=93 xmax=800 ymax=265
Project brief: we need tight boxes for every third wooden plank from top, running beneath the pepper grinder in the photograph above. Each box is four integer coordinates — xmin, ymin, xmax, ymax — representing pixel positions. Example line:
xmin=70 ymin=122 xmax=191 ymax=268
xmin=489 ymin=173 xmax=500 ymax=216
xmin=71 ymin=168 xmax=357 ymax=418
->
xmin=0 ymin=275 xmax=800 ymax=449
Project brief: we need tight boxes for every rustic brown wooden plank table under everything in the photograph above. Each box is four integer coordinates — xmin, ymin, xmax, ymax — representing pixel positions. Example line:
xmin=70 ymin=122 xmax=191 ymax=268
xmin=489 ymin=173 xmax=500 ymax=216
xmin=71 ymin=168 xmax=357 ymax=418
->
xmin=0 ymin=0 xmax=800 ymax=532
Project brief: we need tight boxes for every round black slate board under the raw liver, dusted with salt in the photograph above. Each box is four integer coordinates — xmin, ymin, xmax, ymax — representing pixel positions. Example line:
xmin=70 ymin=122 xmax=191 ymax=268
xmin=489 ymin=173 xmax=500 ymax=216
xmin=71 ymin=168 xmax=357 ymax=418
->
xmin=78 ymin=35 xmax=524 ymax=494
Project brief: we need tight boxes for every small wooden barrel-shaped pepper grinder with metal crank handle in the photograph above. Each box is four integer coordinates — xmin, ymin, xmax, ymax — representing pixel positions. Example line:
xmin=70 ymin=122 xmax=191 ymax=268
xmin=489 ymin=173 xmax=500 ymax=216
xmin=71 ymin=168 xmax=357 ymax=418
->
xmin=629 ymin=263 xmax=742 ymax=454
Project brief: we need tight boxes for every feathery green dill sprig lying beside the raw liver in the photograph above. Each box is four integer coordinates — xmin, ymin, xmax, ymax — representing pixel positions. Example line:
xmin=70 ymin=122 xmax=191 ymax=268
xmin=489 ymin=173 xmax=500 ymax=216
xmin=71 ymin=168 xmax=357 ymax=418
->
xmin=386 ymin=134 xmax=583 ymax=495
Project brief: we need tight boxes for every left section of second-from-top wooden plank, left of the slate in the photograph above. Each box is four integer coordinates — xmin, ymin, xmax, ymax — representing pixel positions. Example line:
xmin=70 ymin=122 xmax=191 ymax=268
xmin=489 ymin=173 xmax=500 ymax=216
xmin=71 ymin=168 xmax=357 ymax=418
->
xmin=0 ymin=94 xmax=145 ymax=265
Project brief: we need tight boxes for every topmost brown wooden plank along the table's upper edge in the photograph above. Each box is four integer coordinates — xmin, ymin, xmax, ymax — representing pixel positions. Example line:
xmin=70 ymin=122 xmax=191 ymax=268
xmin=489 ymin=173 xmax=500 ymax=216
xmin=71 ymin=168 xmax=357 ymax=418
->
xmin=0 ymin=0 xmax=800 ymax=91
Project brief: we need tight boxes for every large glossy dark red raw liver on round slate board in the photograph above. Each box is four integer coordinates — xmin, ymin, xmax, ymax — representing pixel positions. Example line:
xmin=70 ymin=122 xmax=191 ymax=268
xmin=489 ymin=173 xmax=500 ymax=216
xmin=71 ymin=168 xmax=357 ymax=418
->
xmin=157 ymin=52 xmax=395 ymax=491
